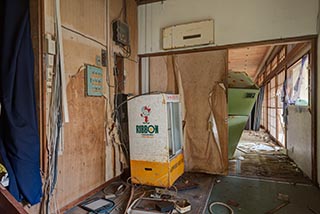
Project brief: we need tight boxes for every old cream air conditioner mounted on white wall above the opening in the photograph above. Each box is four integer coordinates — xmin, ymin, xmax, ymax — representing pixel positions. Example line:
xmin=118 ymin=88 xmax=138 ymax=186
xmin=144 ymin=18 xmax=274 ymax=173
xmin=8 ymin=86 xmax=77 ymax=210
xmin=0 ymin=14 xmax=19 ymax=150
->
xmin=162 ymin=20 xmax=214 ymax=50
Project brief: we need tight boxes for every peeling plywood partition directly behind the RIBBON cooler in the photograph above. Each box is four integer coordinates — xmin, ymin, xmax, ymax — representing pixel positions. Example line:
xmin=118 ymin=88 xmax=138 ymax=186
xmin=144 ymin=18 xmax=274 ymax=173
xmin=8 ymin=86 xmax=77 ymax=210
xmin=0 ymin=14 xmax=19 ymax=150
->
xmin=149 ymin=50 xmax=228 ymax=174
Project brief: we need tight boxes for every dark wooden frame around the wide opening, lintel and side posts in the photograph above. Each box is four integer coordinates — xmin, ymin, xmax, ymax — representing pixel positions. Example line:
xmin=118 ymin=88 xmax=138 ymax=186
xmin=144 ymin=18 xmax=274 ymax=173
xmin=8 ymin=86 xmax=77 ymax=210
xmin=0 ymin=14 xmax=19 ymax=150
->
xmin=138 ymin=35 xmax=319 ymax=186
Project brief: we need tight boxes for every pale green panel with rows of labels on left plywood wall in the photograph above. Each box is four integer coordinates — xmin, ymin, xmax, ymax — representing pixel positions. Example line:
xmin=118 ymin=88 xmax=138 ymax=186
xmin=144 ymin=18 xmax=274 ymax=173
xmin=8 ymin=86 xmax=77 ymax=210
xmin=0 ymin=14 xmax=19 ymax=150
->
xmin=86 ymin=65 xmax=103 ymax=96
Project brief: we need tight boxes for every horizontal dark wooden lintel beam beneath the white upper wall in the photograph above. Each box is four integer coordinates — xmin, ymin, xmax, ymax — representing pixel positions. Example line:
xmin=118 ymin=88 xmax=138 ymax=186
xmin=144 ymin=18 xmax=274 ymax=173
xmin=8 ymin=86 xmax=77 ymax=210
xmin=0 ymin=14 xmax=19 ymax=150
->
xmin=138 ymin=35 xmax=318 ymax=57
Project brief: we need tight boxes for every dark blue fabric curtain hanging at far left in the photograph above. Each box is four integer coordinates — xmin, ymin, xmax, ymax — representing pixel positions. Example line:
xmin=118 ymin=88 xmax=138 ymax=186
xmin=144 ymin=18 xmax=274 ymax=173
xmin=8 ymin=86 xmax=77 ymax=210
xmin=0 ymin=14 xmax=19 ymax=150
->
xmin=0 ymin=0 xmax=42 ymax=205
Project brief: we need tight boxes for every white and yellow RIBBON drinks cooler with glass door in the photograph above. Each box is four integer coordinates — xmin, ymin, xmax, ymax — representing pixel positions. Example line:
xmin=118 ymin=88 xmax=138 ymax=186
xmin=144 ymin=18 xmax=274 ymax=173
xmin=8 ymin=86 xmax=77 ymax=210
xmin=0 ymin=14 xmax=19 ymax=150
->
xmin=128 ymin=94 xmax=184 ymax=187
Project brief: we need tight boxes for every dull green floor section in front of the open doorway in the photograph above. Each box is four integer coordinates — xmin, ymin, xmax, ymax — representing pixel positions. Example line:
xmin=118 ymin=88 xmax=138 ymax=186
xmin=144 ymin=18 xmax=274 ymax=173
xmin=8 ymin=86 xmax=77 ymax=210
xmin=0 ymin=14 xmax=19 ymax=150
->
xmin=205 ymin=176 xmax=320 ymax=214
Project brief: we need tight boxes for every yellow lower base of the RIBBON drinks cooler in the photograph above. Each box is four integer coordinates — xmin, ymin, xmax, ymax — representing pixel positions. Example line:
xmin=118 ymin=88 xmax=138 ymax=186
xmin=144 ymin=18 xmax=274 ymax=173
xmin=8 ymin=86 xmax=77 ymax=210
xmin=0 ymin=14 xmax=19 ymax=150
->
xmin=130 ymin=153 xmax=184 ymax=187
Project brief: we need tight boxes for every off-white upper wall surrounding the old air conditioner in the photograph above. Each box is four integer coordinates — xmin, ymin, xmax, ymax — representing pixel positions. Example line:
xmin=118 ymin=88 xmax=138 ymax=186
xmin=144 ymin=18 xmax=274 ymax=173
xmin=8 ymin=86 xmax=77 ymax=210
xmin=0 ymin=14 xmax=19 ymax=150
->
xmin=138 ymin=0 xmax=318 ymax=54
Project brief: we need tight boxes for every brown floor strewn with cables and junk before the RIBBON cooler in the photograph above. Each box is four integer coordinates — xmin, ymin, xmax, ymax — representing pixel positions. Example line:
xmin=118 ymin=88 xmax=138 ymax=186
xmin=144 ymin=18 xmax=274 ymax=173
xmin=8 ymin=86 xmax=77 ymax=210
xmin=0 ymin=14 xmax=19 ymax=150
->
xmin=66 ymin=173 xmax=216 ymax=214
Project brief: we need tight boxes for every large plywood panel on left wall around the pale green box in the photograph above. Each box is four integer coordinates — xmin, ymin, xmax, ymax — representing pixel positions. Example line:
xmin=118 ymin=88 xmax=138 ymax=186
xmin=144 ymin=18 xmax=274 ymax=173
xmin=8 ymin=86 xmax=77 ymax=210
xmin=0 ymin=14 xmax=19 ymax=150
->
xmin=57 ymin=30 xmax=105 ymax=206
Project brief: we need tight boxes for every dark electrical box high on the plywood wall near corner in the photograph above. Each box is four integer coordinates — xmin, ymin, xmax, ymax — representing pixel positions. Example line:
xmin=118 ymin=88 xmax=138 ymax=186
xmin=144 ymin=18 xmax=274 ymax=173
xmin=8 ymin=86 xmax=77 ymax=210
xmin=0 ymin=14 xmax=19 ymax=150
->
xmin=112 ymin=20 xmax=130 ymax=46
